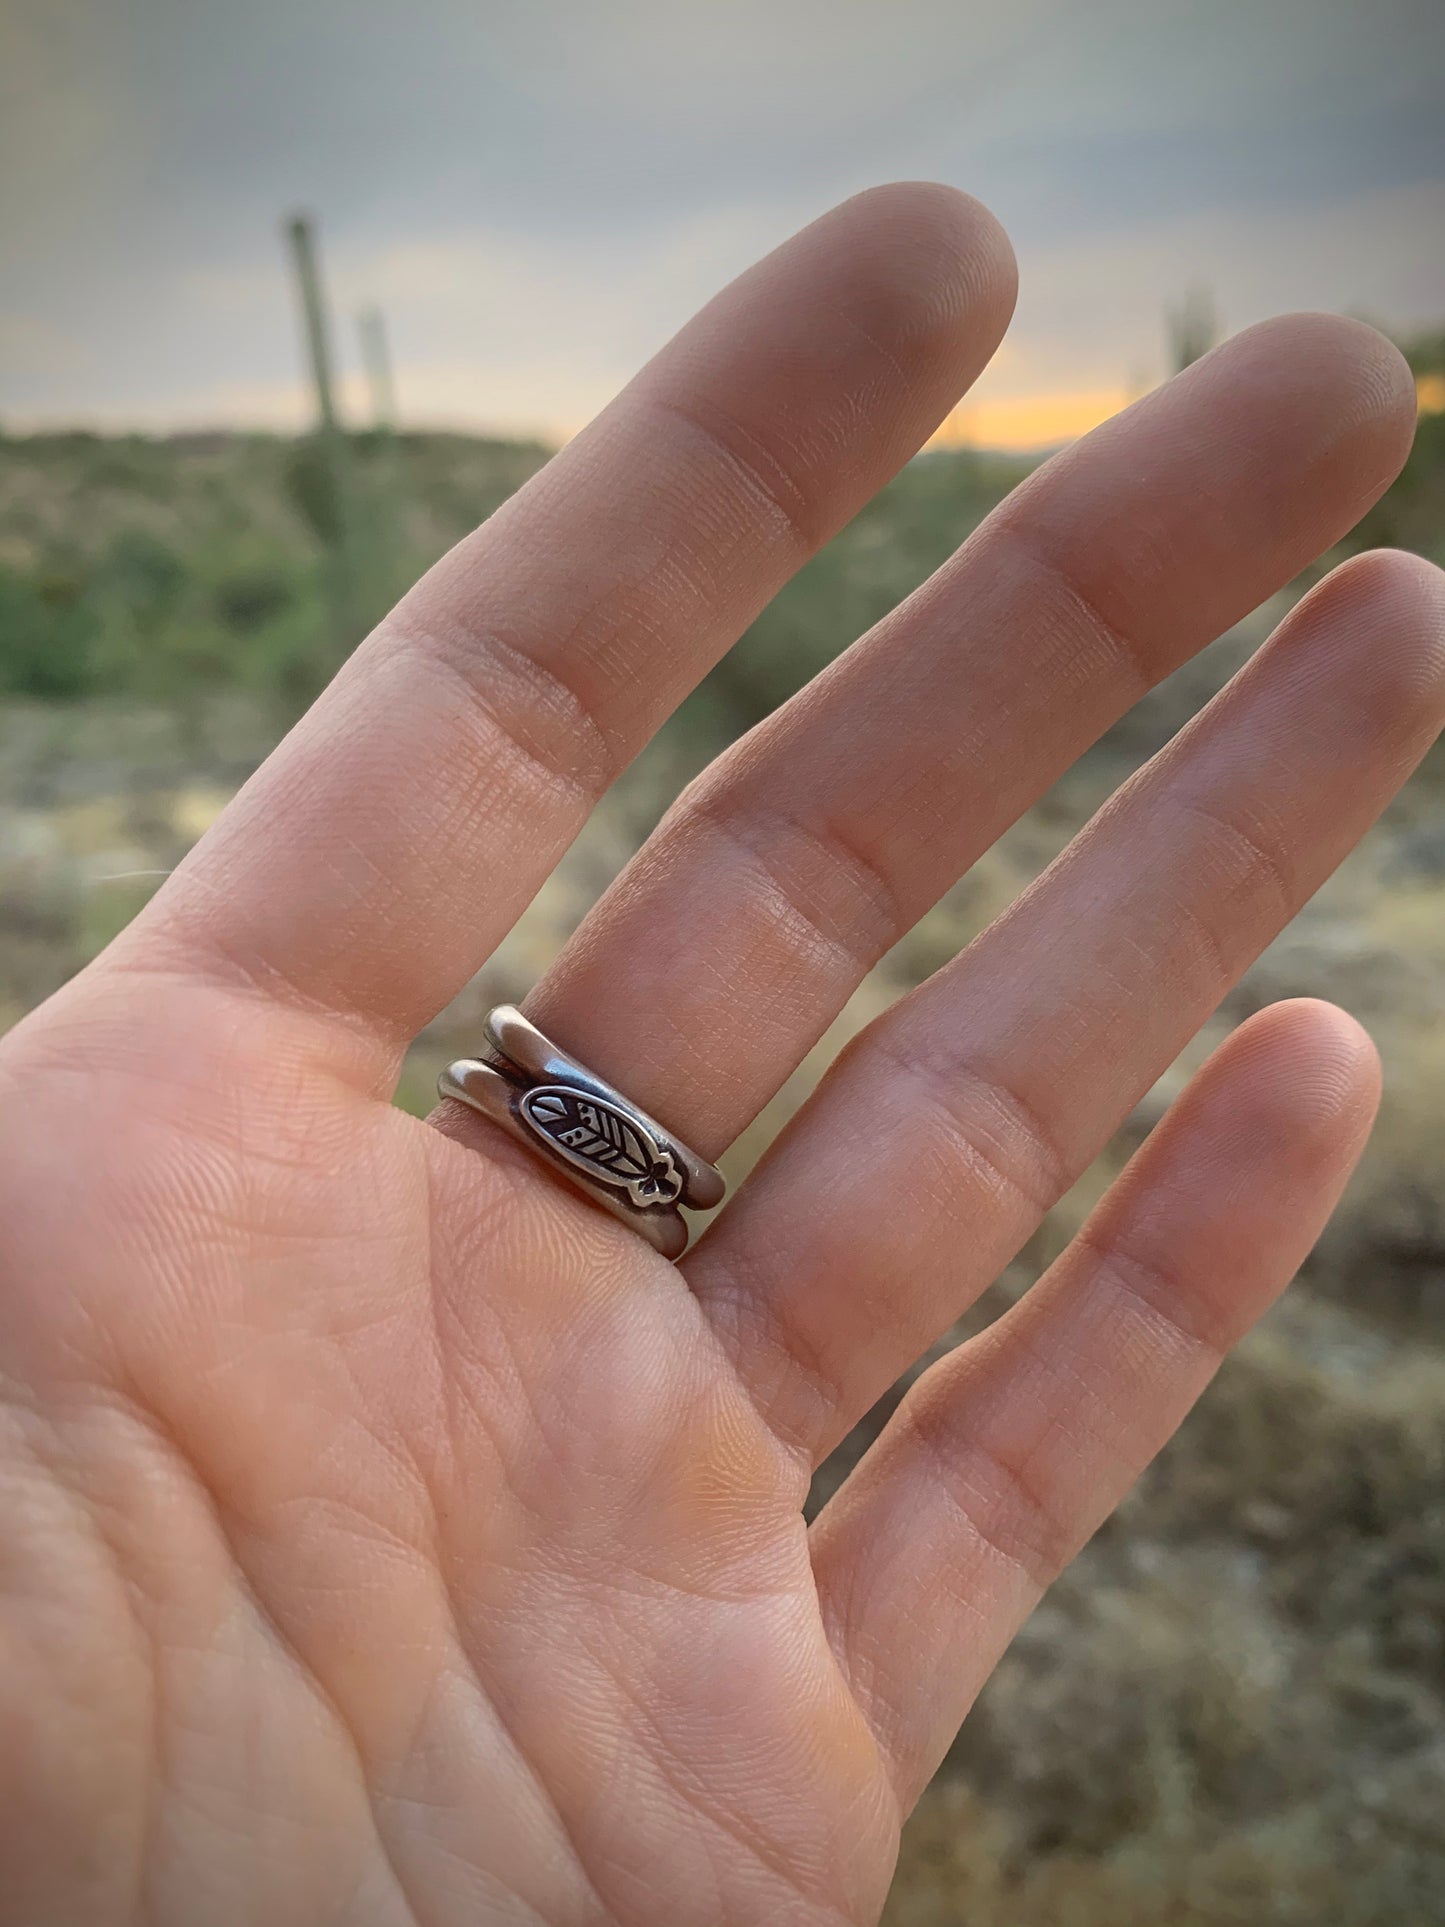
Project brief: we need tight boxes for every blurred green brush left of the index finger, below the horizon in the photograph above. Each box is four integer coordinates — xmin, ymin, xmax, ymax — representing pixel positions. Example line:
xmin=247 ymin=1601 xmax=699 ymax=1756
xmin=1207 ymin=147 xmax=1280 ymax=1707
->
xmin=0 ymin=434 xmax=547 ymax=715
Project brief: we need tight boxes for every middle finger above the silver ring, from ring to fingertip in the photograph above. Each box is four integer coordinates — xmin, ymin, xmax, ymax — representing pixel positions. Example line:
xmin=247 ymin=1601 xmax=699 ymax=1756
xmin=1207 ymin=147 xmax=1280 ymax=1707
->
xmin=528 ymin=316 xmax=1414 ymax=1156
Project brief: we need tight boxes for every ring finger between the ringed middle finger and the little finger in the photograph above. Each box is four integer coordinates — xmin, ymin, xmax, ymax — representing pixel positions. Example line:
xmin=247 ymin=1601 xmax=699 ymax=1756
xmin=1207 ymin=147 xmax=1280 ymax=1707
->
xmin=688 ymin=555 xmax=1445 ymax=1457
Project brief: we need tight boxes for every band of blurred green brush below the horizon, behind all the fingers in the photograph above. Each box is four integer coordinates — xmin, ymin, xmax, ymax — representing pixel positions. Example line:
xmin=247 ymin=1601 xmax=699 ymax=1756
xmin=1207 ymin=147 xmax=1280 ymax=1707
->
xmin=0 ymin=335 xmax=1445 ymax=732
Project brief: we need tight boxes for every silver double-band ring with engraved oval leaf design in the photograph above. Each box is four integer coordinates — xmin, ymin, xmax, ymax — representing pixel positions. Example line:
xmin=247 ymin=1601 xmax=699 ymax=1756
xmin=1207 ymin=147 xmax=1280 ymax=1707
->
xmin=437 ymin=1004 xmax=726 ymax=1258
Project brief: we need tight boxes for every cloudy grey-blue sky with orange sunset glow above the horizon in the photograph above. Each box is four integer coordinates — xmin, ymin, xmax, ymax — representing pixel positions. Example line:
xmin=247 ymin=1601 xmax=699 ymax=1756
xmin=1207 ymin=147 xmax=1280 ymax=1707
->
xmin=0 ymin=0 xmax=1445 ymax=447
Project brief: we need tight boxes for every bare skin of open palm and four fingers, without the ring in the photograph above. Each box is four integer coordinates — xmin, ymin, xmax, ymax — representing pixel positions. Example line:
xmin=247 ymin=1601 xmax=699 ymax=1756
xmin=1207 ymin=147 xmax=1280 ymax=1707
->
xmin=0 ymin=187 xmax=1445 ymax=1927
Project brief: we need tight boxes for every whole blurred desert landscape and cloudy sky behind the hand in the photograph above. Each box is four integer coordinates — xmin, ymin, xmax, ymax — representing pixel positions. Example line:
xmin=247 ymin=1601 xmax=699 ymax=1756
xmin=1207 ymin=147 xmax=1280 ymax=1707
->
xmin=0 ymin=0 xmax=1445 ymax=1927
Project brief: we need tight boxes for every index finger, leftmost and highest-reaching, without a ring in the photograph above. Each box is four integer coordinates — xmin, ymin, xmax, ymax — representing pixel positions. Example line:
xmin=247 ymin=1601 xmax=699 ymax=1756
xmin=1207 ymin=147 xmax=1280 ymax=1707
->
xmin=125 ymin=185 xmax=1013 ymax=1077
